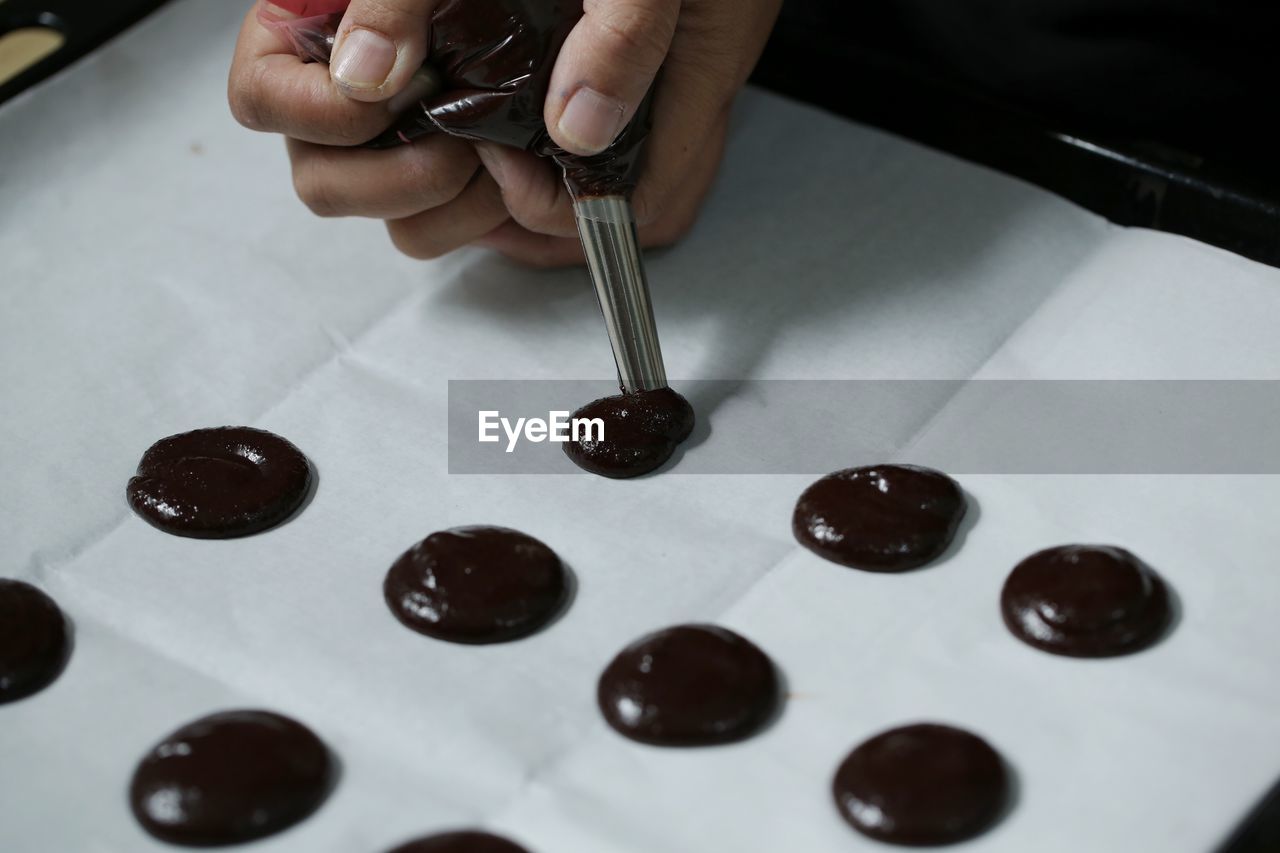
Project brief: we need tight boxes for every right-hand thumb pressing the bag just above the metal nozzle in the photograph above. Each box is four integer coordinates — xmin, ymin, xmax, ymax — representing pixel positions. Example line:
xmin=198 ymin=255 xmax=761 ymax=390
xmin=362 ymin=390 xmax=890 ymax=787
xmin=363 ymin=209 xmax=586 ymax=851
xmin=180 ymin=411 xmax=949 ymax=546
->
xmin=543 ymin=0 xmax=681 ymax=155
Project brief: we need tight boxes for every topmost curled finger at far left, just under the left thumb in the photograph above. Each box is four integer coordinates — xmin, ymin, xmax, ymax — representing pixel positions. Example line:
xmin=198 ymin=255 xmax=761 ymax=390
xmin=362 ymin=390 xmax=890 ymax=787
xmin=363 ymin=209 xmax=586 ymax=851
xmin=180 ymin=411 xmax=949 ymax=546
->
xmin=227 ymin=2 xmax=394 ymax=145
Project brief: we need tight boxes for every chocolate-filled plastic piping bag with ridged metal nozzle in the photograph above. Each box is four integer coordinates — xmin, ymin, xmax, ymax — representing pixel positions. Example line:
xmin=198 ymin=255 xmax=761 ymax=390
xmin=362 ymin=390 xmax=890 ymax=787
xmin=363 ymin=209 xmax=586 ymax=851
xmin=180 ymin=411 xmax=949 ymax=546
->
xmin=266 ymin=0 xmax=667 ymax=393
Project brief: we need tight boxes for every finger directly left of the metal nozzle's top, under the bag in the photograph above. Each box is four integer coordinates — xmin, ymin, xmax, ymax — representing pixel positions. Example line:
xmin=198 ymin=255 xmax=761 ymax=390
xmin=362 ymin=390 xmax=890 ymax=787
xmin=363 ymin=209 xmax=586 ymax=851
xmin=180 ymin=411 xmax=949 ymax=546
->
xmin=476 ymin=142 xmax=577 ymax=237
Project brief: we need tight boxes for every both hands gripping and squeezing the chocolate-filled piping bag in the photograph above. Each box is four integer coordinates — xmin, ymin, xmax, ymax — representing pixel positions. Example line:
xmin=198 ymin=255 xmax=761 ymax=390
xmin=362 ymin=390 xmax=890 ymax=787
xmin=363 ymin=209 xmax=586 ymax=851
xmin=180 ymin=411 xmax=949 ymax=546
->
xmin=229 ymin=0 xmax=781 ymax=265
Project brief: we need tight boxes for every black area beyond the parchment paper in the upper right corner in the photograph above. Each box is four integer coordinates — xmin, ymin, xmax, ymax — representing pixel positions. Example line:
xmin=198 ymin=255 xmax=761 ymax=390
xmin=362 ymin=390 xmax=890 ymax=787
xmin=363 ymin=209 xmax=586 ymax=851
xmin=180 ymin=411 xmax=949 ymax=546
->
xmin=753 ymin=0 xmax=1280 ymax=266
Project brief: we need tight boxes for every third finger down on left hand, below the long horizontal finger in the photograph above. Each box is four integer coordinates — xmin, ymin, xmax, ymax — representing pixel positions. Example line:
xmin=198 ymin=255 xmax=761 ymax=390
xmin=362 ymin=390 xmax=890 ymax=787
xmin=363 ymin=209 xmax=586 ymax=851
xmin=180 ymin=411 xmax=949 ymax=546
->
xmin=387 ymin=169 xmax=509 ymax=260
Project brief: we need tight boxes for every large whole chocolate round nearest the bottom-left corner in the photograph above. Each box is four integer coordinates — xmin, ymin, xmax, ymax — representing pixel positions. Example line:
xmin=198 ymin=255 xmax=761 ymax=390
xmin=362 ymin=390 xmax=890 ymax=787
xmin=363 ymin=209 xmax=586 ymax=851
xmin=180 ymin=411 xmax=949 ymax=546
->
xmin=129 ymin=711 xmax=334 ymax=847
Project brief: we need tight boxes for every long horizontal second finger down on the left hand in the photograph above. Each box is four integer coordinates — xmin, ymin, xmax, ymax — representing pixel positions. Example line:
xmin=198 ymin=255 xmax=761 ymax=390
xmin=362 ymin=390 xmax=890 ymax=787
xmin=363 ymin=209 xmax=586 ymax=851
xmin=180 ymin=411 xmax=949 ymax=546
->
xmin=287 ymin=134 xmax=480 ymax=219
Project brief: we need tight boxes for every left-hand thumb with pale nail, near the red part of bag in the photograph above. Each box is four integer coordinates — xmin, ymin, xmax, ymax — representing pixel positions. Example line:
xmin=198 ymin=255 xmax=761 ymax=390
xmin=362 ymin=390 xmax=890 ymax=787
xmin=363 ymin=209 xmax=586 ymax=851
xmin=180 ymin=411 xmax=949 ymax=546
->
xmin=329 ymin=0 xmax=439 ymax=101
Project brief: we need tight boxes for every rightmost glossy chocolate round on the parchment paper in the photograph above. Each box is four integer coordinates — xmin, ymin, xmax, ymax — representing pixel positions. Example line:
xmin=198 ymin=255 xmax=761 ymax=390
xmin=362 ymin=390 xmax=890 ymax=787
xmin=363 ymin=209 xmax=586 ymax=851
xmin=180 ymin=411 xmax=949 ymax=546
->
xmin=1000 ymin=546 xmax=1171 ymax=657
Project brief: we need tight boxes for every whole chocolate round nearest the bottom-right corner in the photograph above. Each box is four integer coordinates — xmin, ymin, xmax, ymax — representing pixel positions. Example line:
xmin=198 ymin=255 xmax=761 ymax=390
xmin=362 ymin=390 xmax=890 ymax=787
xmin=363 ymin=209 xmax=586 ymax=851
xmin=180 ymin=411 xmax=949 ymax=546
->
xmin=832 ymin=724 xmax=1009 ymax=845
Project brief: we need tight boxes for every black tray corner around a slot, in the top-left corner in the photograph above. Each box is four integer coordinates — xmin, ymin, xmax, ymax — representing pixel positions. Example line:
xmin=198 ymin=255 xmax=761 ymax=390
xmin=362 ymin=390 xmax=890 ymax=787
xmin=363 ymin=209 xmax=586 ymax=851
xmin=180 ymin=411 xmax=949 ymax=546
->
xmin=0 ymin=0 xmax=165 ymax=104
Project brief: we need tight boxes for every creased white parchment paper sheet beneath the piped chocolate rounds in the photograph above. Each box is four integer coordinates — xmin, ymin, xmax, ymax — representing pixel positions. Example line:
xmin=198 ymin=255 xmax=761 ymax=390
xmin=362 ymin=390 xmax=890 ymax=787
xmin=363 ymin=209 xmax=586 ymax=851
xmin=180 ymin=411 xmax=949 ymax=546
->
xmin=0 ymin=0 xmax=1280 ymax=853
